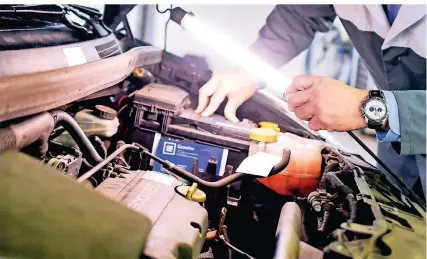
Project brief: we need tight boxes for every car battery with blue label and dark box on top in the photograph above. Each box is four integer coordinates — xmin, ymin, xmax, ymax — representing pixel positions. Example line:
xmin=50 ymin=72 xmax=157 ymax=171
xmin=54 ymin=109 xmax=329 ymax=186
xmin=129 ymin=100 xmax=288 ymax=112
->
xmin=132 ymin=84 xmax=257 ymax=176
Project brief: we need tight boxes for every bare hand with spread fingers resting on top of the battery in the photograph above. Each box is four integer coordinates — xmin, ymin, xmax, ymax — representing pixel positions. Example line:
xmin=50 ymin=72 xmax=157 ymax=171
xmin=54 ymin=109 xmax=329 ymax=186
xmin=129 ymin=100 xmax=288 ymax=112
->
xmin=195 ymin=73 xmax=256 ymax=122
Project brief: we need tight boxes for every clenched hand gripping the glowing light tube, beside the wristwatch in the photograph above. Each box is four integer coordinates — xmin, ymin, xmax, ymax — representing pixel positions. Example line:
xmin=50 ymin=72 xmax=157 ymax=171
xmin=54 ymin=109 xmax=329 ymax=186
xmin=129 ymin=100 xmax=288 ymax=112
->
xmin=286 ymin=76 xmax=369 ymax=131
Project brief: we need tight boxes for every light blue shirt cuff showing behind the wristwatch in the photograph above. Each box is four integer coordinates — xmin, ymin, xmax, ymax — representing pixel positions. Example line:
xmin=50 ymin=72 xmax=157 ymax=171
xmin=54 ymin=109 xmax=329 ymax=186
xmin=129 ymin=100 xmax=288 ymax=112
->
xmin=377 ymin=91 xmax=400 ymax=142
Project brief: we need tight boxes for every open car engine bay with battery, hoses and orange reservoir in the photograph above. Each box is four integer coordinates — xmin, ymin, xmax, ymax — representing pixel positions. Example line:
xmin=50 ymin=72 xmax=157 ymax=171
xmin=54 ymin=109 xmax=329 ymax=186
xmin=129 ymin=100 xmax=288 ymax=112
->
xmin=0 ymin=4 xmax=426 ymax=259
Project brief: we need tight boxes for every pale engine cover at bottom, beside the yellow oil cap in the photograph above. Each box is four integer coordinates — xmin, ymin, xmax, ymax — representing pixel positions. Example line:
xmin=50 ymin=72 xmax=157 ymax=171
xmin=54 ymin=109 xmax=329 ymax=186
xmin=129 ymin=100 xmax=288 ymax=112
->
xmin=96 ymin=171 xmax=208 ymax=259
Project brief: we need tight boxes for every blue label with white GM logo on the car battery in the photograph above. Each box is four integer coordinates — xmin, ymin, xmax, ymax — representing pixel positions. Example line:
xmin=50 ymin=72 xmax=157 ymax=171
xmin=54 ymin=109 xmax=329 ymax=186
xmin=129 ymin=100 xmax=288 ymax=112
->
xmin=153 ymin=137 xmax=228 ymax=176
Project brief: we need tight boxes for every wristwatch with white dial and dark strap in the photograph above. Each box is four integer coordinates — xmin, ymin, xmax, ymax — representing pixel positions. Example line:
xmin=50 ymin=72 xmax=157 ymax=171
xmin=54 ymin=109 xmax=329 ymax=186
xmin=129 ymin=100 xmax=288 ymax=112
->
xmin=361 ymin=90 xmax=388 ymax=130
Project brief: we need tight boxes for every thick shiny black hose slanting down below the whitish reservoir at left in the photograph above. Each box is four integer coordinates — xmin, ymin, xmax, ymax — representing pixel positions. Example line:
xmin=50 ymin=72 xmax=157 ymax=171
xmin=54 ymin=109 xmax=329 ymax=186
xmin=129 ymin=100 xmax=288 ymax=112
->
xmin=50 ymin=111 xmax=103 ymax=164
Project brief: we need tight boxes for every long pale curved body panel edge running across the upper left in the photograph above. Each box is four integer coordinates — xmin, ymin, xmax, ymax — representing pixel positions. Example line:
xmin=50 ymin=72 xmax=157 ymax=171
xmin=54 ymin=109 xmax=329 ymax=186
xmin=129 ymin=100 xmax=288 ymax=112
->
xmin=0 ymin=47 xmax=161 ymax=122
